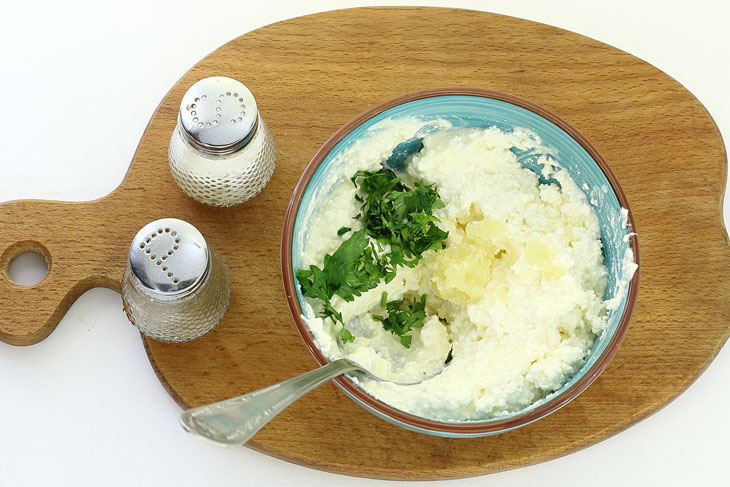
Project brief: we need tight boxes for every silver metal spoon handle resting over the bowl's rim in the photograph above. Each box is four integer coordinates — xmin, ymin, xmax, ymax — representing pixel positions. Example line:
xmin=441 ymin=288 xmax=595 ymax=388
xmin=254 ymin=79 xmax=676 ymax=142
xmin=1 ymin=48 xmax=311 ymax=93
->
xmin=180 ymin=359 xmax=359 ymax=446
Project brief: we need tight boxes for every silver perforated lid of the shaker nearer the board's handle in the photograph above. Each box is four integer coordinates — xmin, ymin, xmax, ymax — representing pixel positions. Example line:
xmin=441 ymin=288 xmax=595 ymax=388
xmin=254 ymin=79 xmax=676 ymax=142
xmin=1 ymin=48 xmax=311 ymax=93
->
xmin=129 ymin=218 xmax=210 ymax=298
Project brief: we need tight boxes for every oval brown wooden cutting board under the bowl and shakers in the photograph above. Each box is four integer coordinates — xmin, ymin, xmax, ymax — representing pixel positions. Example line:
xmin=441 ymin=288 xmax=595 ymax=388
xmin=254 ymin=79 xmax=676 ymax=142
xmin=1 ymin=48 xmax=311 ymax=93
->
xmin=0 ymin=8 xmax=730 ymax=479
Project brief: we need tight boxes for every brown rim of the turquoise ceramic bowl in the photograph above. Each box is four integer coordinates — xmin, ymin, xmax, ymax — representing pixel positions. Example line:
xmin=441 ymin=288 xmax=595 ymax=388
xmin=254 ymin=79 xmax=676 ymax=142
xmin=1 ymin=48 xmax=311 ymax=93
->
xmin=281 ymin=87 xmax=641 ymax=435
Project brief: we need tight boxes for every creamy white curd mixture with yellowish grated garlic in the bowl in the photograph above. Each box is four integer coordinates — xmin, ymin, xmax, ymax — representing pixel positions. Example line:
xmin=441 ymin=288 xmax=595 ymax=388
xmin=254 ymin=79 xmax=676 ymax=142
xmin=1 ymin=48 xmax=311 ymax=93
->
xmin=302 ymin=119 xmax=635 ymax=420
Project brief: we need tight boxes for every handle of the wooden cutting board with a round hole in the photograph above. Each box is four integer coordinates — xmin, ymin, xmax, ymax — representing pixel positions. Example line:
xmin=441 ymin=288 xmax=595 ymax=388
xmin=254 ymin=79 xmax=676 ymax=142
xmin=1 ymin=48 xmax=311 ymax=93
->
xmin=0 ymin=198 xmax=126 ymax=345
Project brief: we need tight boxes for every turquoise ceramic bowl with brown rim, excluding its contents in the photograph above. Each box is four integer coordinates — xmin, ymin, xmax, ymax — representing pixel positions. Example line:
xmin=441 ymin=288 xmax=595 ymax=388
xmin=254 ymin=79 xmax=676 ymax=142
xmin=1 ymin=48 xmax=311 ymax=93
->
xmin=281 ymin=88 xmax=639 ymax=437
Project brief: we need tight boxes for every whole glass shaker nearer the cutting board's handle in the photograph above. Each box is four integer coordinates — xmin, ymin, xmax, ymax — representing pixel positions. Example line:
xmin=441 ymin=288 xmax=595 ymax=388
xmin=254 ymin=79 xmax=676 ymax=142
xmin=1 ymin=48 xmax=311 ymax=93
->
xmin=122 ymin=218 xmax=231 ymax=343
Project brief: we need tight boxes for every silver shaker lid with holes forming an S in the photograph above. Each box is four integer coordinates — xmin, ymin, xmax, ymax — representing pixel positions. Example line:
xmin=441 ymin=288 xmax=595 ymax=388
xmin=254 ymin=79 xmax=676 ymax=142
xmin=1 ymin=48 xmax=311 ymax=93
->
xmin=180 ymin=76 xmax=258 ymax=155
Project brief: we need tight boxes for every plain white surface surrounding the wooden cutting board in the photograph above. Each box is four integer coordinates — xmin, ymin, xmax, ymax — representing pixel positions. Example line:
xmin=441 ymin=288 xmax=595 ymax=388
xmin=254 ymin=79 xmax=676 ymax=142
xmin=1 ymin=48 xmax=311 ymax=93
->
xmin=0 ymin=0 xmax=730 ymax=487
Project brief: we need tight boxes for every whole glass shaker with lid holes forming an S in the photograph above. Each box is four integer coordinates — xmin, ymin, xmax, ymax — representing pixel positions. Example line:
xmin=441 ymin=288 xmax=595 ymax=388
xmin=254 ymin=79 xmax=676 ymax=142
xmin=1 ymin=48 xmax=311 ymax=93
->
xmin=168 ymin=76 xmax=276 ymax=206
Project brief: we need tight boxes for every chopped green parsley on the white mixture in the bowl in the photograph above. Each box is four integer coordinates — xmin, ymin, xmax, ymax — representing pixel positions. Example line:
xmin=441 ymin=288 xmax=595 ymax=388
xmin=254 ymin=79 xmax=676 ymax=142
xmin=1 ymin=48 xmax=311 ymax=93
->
xmin=296 ymin=168 xmax=448 ymax=347
